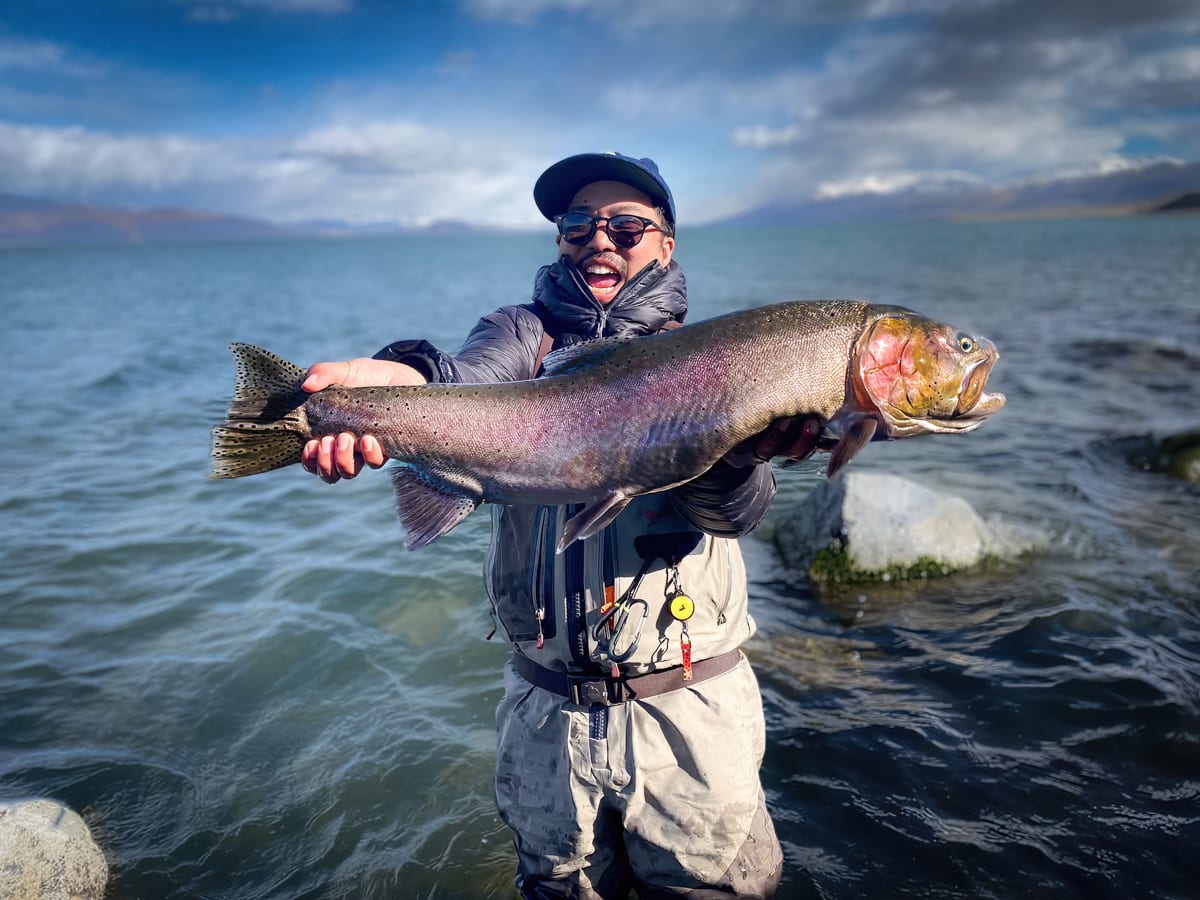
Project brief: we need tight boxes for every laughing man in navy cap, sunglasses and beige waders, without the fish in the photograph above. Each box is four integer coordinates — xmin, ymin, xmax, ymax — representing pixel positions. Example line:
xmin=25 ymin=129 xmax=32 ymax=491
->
xmin=304 ymin=154 xmax=817 ymax=898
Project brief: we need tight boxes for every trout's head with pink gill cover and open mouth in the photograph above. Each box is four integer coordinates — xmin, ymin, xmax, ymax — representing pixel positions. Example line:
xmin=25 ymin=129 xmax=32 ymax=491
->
xmin=852 ymin=307 xmax=1004 ymax=438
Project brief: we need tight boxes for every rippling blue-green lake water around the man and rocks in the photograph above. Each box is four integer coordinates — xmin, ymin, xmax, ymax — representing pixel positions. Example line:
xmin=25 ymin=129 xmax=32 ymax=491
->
xmin=0 ymin=216 xmax=1200 ymax=900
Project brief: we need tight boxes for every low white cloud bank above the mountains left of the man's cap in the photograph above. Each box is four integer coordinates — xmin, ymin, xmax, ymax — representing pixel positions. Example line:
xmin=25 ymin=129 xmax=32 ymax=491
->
xmin=0 ymin=120 xmax=549 ymax=227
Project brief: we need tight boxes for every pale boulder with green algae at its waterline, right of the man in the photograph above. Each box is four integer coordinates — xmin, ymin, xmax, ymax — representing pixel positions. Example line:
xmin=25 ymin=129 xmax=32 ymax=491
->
xmin=775 ymin=472 xmax=1036 ymax=583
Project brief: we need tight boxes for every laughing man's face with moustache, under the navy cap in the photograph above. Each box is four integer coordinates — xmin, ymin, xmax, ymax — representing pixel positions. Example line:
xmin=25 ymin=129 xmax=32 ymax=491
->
xmin=557 ymin=181 xmax=674 ymax=304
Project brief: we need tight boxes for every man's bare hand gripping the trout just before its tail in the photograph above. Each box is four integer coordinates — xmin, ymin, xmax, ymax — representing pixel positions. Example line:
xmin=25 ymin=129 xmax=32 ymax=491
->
xmin=300 ymin=358 xmax=426 ymax=484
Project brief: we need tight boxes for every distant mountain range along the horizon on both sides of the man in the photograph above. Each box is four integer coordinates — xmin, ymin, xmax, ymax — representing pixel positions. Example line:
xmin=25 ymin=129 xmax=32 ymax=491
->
xmin=0 ymin=162 xmax=1200 ymax=246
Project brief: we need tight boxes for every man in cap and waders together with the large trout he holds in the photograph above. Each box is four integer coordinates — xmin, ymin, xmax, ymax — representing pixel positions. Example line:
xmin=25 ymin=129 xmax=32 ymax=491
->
xmin=212 ymin=154 xmax=1004 ymax=898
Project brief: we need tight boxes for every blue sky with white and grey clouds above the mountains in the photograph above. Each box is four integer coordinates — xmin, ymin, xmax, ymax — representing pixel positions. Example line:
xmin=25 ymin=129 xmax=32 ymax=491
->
xmin=0 ymin=0 xmax=1200 ymax=227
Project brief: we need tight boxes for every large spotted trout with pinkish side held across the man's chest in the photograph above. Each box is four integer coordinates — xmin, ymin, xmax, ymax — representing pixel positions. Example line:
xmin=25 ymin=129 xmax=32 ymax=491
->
xmin=212 ymin=300 xmax=1004 ymax=552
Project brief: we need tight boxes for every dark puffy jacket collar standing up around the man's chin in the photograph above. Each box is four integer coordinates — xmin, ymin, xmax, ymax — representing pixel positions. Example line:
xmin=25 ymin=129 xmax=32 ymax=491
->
xmin=533 ymin=257 xmax=688 ymax=337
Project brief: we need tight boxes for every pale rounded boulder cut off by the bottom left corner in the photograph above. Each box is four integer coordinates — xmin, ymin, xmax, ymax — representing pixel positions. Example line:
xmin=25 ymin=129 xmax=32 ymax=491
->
xmin=0 ymin=799 xmax=108 ymax=900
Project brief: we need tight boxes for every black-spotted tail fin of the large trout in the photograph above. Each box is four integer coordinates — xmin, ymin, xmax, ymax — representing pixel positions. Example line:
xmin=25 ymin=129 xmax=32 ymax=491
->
xmin=211 ymin=343 xmax=310 ymax=478
